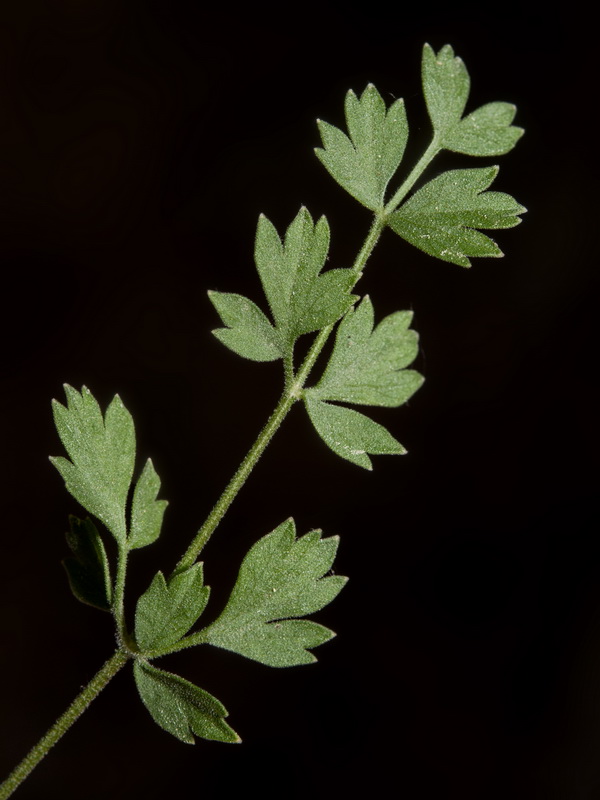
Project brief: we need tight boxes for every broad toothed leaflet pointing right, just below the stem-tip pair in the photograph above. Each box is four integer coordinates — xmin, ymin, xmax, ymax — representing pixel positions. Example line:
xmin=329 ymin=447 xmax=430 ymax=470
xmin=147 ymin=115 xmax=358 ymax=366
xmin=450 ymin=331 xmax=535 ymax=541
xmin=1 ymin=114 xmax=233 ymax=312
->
xmin=389 ymin=167 xmax=526 ymax=267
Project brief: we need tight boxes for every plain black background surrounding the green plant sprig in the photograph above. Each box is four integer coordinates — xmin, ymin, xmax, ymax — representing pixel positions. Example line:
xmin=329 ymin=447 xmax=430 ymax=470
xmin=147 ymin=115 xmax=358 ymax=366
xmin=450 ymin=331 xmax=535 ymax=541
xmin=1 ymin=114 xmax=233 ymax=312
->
xmin=0 ymin=0 xmax=600 ymax=800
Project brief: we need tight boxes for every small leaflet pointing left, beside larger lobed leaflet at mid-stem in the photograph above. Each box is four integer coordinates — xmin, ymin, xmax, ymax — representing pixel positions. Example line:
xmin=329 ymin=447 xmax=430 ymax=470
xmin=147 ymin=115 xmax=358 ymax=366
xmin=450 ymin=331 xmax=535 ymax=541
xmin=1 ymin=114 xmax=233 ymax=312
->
xmin=208 ymin=292 xmax=284 ymax=361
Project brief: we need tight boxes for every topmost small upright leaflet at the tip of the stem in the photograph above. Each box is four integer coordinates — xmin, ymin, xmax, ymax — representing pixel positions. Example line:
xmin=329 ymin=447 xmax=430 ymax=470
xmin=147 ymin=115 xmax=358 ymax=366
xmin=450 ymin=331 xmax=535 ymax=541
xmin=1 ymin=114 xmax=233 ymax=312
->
xmin=422 ymin=44 xmax=471 ymax=139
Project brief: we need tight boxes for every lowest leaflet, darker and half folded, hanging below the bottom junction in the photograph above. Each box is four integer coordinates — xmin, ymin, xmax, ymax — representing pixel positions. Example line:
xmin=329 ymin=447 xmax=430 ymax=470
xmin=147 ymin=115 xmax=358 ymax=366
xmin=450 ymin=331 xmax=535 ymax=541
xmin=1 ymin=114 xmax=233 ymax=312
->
xmin=133 ymin=660 xmax=241 ymax=744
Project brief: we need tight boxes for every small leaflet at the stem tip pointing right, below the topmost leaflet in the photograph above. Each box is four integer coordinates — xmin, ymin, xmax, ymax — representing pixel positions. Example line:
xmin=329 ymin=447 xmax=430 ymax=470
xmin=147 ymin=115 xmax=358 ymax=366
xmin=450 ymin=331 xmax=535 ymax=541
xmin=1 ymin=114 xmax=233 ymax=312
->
xmin=444 ymin=103 xmax=524 ymax=156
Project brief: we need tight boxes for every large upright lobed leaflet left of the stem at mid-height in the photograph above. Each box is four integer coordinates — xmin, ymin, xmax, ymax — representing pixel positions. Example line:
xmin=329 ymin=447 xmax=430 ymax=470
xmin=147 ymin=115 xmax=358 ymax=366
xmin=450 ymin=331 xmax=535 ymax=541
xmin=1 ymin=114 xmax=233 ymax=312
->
xmin=254 ymin=208 xmax=355 ymax=352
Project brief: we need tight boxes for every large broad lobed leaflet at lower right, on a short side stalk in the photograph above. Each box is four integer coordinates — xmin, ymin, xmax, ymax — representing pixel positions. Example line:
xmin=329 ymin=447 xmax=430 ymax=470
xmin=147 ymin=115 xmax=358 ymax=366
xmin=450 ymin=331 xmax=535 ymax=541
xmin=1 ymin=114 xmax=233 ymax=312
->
xmin=205 ymin=519 xmax=347 ymax=667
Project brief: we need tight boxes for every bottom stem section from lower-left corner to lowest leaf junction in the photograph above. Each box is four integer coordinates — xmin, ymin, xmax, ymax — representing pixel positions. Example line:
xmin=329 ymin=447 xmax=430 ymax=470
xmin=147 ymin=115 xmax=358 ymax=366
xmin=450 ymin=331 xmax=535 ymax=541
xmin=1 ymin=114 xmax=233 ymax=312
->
xmin=0 ymin=650 xmax=129 ymax=800
